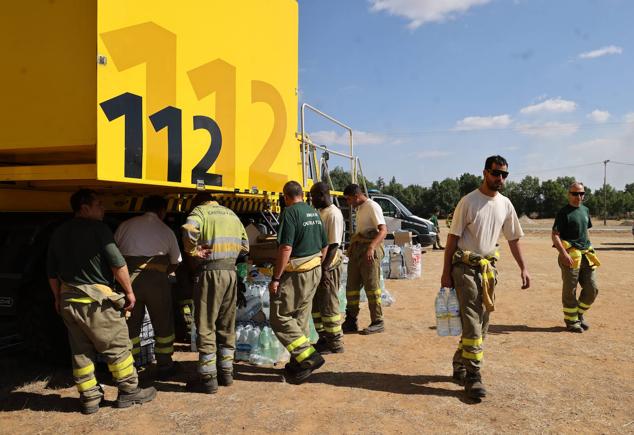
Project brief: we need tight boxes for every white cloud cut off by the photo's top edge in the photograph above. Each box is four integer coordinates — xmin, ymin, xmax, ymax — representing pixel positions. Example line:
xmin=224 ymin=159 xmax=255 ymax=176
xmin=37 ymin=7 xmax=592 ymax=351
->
xmin=370 ymin=0 xmax=491 ymax=29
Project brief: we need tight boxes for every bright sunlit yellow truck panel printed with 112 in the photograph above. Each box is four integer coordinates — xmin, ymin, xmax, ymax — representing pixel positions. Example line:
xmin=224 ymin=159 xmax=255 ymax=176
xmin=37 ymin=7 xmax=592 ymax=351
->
xmin=96 ymin=0 xmax=301 ymax=192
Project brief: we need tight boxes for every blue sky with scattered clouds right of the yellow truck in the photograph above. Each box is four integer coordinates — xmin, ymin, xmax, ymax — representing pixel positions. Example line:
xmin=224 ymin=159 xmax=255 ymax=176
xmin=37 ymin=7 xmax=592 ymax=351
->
xmin=299 ymin=0 xmax=634 ymax=189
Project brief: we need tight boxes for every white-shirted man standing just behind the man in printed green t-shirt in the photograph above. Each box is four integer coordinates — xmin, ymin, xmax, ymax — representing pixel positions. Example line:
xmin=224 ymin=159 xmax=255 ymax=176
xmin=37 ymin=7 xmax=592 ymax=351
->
xmin=310 ymin=182 xmax=345 ymax=355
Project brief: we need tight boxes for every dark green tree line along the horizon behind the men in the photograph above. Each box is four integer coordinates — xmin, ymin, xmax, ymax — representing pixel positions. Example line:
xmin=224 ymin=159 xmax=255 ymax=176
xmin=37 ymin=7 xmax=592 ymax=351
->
xmin=330 ymin=167 xmax=634 ymax=219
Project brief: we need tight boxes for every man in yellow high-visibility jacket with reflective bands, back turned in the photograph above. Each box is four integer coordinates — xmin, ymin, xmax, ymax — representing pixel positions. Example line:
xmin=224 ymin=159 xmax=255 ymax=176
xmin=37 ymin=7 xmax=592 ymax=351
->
xmin=183 ymin=193 xmax=249 ymax=394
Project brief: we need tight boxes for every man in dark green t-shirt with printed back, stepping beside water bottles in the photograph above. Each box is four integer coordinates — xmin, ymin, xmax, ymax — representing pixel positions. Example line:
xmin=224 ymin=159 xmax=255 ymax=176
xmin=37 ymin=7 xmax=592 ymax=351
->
xmin=269 ymin=181 xmax=328 ymax=384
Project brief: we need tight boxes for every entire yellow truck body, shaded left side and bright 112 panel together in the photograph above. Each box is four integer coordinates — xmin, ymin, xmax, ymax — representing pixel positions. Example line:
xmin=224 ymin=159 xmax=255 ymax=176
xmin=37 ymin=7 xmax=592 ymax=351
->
xmin=0 ymin=0 xmax=302 ymax=211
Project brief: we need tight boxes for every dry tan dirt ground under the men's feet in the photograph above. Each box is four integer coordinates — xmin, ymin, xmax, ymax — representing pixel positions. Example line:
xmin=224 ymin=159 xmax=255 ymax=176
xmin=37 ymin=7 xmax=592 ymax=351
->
xmin=0 ymin=225 xmax=634 ymax=433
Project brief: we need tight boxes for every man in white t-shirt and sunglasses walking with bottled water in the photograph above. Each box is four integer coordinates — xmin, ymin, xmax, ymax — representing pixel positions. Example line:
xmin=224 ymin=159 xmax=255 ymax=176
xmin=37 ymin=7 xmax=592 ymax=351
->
xmin=441 ymin=156 xmax=530 ymax=400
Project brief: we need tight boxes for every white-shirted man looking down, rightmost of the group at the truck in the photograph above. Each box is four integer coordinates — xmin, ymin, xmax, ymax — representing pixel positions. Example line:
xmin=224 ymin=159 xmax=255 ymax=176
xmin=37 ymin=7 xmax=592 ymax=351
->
xmin=342 ymin=184 xmax=387 ymax=335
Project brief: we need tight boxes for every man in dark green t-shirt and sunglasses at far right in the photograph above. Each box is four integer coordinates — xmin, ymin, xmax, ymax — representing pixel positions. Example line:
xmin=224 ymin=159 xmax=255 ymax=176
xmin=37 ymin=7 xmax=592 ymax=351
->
xmin=552 ymin=181 xmax=600 ymax=333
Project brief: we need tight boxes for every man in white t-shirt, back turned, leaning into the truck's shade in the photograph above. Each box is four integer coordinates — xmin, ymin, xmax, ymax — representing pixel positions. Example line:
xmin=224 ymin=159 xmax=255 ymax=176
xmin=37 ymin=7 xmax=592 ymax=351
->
xmin=114 ymin=196 xmax=182 ymax=380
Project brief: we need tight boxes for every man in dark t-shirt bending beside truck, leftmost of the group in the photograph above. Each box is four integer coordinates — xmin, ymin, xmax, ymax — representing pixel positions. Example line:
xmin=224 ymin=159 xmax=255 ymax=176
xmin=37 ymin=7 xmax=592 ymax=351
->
xmin=47 ymin=189 xmax=156 ymax=414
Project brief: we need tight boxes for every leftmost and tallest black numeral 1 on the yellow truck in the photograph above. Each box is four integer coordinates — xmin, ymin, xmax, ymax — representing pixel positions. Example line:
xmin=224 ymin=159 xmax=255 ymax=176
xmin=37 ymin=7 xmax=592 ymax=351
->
xmin=100 ymin=92 xmax=143 ymax=178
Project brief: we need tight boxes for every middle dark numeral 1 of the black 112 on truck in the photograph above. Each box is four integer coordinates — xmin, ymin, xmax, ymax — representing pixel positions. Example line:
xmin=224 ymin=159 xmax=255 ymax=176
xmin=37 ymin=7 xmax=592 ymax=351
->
xmin=150 ymin=106 xmax=183 ymax=182
